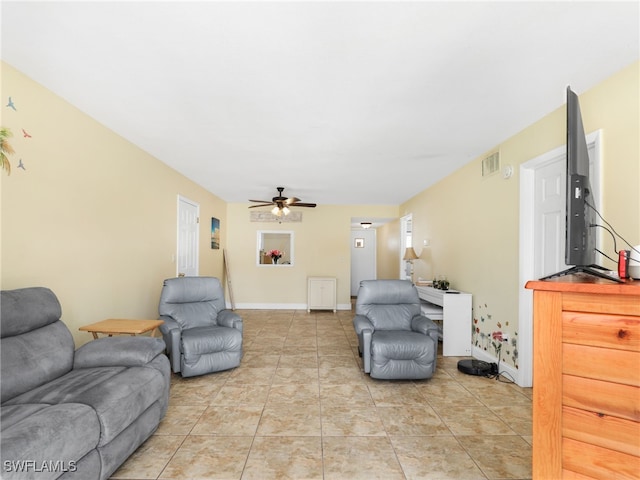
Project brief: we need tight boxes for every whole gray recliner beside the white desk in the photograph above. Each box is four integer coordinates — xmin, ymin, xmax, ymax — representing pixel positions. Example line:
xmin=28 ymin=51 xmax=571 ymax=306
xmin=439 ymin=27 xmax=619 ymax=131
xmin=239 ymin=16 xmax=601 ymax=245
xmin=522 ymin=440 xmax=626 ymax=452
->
xmin=353 ymin=280 xmax=438 ymax=380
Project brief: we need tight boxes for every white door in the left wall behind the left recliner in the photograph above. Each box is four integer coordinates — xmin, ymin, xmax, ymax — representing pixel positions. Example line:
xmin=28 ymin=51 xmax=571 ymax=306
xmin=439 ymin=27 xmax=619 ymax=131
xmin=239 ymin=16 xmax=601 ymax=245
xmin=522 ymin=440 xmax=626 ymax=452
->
xmin=176 ymin=195 xmax=200 ymax=277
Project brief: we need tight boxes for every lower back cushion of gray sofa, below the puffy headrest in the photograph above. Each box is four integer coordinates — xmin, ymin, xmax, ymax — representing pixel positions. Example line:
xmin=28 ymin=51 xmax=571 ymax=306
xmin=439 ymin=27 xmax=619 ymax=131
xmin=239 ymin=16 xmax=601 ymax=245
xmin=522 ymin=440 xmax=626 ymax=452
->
xmin=0 ymin=320 xmax=74 ymax=403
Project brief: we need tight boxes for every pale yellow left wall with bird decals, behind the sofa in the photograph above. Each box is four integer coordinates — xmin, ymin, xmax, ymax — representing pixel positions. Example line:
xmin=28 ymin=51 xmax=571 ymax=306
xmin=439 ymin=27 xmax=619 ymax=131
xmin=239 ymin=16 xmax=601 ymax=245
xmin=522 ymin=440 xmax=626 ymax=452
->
xmin=0 ymin=63 xmax=226 ymax=344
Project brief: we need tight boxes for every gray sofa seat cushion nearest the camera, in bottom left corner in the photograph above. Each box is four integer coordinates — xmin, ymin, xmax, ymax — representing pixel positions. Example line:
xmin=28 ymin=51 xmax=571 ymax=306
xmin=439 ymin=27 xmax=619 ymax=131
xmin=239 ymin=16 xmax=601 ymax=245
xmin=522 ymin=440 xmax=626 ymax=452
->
xmin=0 ymin=403 xmax=100 ymax=480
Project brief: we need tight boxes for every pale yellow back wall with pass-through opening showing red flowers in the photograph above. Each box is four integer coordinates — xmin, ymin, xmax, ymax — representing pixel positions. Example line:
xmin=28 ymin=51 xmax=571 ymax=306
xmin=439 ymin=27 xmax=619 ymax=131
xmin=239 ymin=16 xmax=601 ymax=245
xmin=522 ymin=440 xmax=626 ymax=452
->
xmin=227 ymin=199 xmax=398 ymax=308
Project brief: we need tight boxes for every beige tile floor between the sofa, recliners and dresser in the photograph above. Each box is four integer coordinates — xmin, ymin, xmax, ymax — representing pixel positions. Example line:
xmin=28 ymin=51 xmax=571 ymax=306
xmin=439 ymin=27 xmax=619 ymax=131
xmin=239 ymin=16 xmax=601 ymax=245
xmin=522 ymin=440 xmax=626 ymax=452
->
xmin=112 ymin=310 xmax=532 ymax=480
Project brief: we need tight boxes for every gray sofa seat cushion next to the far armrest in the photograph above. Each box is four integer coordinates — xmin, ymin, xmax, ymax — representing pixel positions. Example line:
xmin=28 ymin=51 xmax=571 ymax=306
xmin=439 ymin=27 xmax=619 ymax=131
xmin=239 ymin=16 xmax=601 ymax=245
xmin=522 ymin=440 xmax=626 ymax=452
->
xmin=3 ymin=367 xmax=165 ymax=446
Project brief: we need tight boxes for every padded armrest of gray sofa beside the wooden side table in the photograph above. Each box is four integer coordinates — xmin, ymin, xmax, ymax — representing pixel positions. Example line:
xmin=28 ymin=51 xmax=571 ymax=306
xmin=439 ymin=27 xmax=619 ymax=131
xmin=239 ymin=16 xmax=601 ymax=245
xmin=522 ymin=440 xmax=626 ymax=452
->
xmin=73 ymin=336 xmax=165 ymax=369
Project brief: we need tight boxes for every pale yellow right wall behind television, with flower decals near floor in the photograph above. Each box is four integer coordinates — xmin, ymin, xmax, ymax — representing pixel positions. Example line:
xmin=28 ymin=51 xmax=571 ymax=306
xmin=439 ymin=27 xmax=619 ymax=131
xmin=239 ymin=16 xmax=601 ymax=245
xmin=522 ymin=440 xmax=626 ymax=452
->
xmin=400 ymin=63 xmax=640 ymax=366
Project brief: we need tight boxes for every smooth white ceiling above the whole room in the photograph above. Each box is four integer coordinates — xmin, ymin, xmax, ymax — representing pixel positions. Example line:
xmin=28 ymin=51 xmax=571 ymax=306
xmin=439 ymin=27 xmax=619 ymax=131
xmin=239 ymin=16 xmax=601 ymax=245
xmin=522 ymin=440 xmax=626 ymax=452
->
xmin=0 ymin=1 xmax=640 ymax=205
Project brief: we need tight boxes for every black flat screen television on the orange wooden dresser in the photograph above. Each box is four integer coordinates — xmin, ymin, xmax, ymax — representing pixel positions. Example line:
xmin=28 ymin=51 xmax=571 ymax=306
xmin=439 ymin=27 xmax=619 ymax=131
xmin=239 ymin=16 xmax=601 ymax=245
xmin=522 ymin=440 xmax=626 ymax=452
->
xmin=543 ymin=87 xmax=621 ymax=282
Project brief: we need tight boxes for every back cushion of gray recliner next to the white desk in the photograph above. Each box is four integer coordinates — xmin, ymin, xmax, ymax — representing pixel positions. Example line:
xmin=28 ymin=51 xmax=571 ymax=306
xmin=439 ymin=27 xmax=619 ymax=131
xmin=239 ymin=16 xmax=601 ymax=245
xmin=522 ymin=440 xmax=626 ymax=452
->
xmin=356 ymin=280 xmax=420 ymax=330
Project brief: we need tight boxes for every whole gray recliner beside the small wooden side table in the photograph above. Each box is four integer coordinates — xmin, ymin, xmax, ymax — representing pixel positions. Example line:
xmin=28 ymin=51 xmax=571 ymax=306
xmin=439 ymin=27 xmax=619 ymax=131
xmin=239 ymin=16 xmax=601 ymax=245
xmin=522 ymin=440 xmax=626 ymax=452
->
xmin=158 ymin=277 xmax=242 ymax=377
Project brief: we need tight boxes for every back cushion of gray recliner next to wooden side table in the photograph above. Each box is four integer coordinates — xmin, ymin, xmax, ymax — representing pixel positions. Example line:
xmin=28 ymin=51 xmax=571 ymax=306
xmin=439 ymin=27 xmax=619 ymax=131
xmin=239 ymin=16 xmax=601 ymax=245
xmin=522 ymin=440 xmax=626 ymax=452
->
xmin=158 ymin=277 xmax=225 ymax=329
